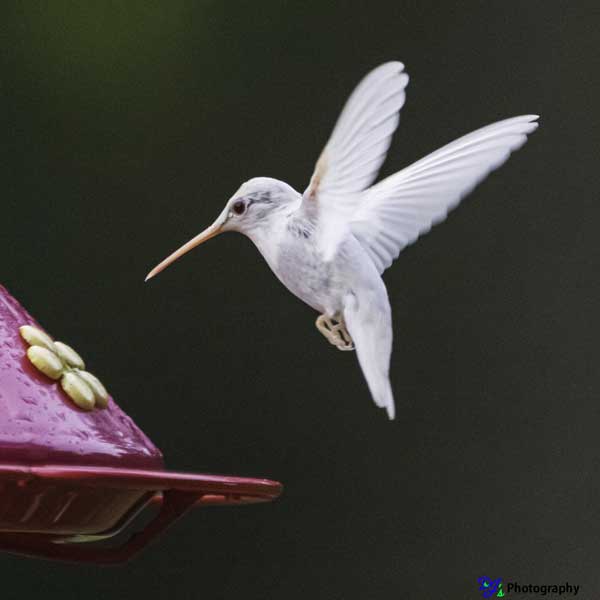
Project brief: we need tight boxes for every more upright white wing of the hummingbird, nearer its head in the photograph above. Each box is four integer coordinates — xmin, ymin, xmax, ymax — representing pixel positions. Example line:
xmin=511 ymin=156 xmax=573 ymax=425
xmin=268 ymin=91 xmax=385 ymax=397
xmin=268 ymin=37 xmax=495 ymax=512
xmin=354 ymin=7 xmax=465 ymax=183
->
xmin=300 ymin=62 xmax=408 ymax=256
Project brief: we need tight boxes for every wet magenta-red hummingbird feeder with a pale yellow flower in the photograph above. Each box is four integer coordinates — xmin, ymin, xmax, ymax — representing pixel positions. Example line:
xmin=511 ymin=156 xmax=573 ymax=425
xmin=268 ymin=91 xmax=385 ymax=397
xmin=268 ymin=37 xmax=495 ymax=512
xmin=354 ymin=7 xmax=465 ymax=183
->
xmin=0 ymin=286 xmax=282 ymax=563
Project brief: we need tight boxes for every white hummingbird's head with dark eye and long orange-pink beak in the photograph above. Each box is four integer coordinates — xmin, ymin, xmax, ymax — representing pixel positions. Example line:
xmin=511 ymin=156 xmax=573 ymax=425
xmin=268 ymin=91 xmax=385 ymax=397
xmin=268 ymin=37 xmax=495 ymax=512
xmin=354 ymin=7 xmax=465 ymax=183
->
xmin=146 ymin=177 xmax=301 ymax=281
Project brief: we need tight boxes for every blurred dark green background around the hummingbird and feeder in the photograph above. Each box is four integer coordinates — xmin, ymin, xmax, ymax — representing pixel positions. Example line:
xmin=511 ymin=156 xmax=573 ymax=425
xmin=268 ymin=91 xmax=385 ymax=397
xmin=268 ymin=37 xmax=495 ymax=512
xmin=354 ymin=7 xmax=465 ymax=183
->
xmin=0 ymin=0 xmax=600 ymax=600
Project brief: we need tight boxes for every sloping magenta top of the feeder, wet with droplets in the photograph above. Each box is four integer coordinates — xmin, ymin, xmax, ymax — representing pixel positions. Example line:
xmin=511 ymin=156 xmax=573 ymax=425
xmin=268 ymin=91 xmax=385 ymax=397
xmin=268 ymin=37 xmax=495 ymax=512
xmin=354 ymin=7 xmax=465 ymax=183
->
xmin=0 ymin=285 xmax=163 ymax=468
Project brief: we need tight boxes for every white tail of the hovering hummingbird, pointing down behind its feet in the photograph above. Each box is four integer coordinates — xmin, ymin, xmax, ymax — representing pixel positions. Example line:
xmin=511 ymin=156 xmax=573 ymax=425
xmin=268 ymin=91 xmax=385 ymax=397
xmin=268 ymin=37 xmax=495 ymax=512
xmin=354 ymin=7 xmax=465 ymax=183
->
xmin=344 ymin=290 xmax=396 ymax=419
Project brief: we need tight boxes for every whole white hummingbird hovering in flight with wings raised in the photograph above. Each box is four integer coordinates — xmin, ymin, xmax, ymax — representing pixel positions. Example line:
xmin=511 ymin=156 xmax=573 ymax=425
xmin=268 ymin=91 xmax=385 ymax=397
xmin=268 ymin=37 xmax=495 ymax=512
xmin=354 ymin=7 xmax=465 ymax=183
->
xmin=146 ymin=61 xmax=538 ymax=419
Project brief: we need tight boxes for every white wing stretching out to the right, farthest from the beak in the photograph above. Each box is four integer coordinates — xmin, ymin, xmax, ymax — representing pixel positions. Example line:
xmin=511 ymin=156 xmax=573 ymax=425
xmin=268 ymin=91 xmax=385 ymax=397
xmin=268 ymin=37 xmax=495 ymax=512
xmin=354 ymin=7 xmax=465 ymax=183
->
xmin=350 ymin=115 xmax=538 ymax=273
